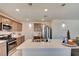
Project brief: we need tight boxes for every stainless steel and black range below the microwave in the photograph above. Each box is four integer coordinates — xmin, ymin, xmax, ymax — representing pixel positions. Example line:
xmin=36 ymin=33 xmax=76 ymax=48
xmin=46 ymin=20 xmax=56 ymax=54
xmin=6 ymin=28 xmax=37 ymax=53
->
xmin=0 ymin=34 xmax=16 ymax=55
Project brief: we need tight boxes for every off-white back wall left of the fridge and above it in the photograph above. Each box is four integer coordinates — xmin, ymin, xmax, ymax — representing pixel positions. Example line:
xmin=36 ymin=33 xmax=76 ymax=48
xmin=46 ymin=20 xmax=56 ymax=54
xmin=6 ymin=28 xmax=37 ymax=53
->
xmin=23 ymin=21 xmax=50 ymax=39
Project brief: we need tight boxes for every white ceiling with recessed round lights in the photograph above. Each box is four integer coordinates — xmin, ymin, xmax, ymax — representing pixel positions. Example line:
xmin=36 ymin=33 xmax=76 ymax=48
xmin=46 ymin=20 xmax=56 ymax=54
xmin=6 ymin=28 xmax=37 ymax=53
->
xmin=0 ymin=3 xmax=79 ymax=21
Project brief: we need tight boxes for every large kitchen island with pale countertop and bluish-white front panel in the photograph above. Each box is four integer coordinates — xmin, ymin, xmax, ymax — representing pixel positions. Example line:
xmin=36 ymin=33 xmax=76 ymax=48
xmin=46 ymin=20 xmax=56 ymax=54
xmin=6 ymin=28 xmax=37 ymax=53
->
xmin=12 ymin=39 xmax=78 ymax=56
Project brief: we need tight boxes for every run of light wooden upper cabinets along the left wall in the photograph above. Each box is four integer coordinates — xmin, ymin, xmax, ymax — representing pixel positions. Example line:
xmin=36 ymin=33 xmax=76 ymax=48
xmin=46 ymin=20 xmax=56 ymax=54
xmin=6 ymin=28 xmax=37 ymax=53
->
xmin=0 ymin=16 xmax=22 ymax=32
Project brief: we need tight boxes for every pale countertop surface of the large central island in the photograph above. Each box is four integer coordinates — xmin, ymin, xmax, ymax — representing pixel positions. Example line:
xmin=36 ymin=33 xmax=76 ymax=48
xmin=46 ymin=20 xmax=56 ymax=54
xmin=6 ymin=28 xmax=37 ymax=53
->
xmin=17 ymin=39 xmax=71 ymax=49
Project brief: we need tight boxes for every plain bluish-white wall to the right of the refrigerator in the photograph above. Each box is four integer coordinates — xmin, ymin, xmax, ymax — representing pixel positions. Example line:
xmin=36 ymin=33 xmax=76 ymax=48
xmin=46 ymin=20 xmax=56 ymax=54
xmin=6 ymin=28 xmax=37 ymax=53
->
xmin=51 ymin=19 xmax=79 ymax=39
